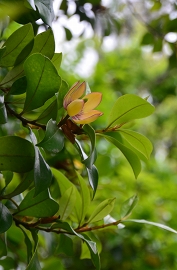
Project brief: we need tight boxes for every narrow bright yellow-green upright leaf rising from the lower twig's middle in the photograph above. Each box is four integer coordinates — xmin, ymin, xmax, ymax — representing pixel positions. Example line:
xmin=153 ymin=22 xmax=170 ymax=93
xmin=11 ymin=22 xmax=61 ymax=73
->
xmin=76 ymin=172 xmax=90 ymax=223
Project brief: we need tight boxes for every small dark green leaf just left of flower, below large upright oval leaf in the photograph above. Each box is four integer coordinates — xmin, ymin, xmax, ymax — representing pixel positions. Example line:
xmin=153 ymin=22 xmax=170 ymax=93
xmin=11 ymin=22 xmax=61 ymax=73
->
xmin=36 ymin=99 xmax=58 ymax=124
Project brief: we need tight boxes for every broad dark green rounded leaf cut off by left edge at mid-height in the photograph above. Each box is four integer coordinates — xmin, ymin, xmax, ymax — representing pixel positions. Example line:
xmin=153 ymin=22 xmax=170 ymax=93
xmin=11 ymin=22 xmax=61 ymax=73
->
xmin=0 ymin=136 xmax=35 ymax=173
